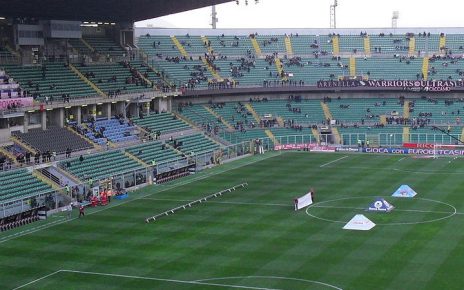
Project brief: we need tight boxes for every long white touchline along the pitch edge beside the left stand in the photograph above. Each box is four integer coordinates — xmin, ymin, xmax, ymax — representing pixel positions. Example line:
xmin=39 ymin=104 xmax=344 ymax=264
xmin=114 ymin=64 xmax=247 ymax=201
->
xmin=0 ymin=154 xmax=278 ymax=244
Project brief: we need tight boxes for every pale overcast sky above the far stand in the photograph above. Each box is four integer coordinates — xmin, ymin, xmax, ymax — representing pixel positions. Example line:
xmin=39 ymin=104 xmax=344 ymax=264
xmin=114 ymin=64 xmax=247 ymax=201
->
xmin=136 ymin=0 xmax=464 ymax=28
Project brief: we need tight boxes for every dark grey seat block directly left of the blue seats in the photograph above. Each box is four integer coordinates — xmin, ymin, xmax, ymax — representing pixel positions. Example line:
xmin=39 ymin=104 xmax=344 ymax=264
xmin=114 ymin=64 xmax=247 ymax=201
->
xmin=12 ymin=127 xmax=93 ymax=154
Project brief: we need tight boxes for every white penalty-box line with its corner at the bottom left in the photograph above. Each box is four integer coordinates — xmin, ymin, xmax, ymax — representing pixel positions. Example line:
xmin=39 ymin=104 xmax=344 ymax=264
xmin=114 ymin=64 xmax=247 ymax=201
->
xmin=13 ymin=270 xmax=284 ymax=290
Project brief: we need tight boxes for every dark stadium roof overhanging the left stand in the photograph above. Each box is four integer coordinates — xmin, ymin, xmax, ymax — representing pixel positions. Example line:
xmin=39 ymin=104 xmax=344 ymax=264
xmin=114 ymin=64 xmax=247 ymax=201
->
xmin=0 ymin=0 xmax=231 ymax=22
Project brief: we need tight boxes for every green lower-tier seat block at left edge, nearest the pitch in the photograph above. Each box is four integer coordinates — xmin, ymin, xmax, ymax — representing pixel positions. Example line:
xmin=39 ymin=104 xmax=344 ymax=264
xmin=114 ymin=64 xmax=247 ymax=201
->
xmin=0 ymin=169 xmax=53 ymax=202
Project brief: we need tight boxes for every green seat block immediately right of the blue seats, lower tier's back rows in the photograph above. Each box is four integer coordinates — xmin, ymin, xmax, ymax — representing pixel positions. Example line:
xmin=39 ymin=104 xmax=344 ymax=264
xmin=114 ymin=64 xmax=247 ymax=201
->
xmin=132 ymin=113 xmax=191 ymax=134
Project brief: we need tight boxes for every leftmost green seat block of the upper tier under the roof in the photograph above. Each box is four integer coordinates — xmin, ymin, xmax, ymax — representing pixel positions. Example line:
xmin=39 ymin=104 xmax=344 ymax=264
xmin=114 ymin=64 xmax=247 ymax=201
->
xmin=3 ymin=63 xmax=98 ymax=100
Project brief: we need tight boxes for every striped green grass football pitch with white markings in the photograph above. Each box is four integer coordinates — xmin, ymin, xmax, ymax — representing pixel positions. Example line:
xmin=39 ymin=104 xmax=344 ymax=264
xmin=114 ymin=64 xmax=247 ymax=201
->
xmin=0 ymin=152 xmax=464 ymax=290
